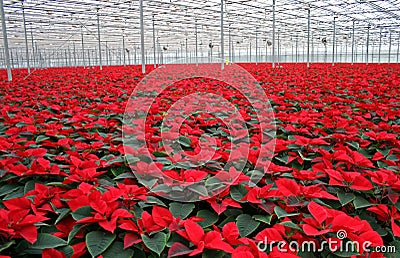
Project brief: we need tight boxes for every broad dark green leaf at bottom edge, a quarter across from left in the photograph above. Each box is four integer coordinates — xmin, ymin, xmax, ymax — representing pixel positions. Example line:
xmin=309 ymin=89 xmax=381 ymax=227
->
xmin=86 ymin=231 xmax=116 ymax=257
